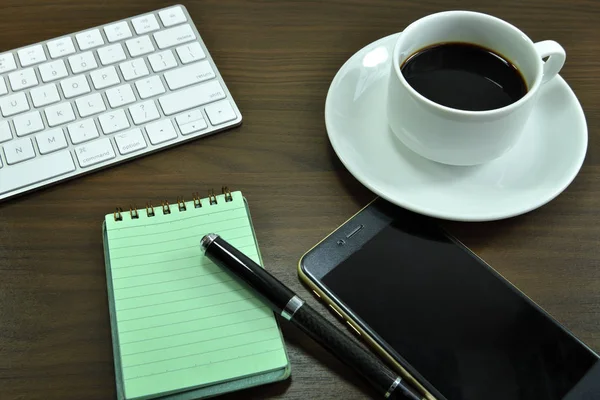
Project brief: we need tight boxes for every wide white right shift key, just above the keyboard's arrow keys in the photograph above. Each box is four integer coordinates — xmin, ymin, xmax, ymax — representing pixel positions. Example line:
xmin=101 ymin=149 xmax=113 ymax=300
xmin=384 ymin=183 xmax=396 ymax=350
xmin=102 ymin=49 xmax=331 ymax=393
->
xmin=158 ymin=81 xmax=225 ymax=115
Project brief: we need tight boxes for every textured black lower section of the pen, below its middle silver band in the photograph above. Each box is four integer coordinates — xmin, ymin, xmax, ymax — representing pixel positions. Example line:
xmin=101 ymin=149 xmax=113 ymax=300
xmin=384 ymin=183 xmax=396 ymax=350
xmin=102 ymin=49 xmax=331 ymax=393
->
xmin=291 ymin=304 xmax=423 ymax=400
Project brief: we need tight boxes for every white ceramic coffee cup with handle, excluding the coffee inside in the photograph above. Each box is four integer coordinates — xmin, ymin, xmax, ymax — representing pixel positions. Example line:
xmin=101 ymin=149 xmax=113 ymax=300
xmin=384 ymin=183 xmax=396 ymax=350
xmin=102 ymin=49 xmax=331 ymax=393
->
xmin=387 ymin=11 xmax=566 ymax=165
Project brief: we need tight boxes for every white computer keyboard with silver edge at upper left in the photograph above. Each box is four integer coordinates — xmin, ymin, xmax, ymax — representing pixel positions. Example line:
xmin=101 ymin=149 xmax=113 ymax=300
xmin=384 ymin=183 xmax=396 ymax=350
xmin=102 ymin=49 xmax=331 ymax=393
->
xmin=0 ymin=5 xmax=242 ymax=200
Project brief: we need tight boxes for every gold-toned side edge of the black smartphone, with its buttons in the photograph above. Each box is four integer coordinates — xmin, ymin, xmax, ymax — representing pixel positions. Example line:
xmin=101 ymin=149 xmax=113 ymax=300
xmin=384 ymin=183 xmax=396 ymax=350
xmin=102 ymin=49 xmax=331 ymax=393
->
xmin=298 ymin=197 xmax=437 ymax=400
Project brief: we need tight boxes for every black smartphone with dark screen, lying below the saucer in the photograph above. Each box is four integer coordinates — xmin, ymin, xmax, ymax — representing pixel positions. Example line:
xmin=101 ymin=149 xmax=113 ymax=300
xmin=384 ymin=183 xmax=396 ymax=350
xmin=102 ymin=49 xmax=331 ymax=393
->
xmin=298 ymin=198 xmax=600 ymax=400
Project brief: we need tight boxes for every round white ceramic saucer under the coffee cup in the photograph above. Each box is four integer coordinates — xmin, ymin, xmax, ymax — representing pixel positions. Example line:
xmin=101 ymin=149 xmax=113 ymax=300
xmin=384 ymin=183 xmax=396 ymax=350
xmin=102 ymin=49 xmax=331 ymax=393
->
xmin=325 ymin=34 xmax=587 ymax=221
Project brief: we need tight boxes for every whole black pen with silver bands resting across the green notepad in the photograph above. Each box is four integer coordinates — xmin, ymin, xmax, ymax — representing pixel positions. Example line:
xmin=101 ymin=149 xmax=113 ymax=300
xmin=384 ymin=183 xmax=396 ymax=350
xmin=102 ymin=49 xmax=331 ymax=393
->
xmin=200 ymin=233 xmax=424 ymax=400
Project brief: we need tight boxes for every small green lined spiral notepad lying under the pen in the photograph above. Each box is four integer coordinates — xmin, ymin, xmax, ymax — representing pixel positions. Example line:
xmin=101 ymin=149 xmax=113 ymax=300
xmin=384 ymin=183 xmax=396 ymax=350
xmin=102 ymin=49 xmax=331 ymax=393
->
xmin=105 ymin=192 xmax=289 ymax=399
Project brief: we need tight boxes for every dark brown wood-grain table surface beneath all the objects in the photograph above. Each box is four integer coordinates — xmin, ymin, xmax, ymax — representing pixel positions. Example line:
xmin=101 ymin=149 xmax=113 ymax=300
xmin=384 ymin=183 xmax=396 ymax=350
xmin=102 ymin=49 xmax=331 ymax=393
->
xmin=0 ymin=0 xmax=600 ymax=400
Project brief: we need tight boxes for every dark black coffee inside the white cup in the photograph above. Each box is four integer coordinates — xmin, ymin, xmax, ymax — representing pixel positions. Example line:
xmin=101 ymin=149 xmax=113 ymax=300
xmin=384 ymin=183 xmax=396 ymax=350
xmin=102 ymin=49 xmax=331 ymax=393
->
xmin=400 ymin=43 xmax=527 ymax=111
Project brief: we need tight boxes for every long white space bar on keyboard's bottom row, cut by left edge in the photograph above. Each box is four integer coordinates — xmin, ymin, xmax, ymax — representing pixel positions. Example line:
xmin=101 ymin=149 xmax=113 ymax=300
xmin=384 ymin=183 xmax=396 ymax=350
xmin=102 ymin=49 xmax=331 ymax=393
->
xmin=0 ymin=150 xmax=75 ymax=194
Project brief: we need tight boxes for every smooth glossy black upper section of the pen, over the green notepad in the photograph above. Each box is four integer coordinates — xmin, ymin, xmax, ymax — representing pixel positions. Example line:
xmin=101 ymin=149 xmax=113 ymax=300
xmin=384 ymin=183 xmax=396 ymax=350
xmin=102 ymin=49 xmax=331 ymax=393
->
xmin=205 ymin=237 xmax=295 ymax=313
